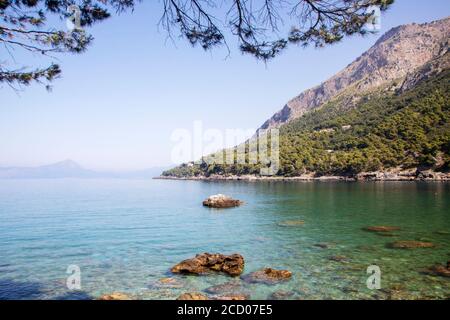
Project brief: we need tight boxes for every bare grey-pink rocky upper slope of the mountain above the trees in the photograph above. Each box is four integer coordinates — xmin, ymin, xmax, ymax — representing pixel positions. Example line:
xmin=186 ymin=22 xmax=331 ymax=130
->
xmin=261 ymin=18 xmax=450 ymax=129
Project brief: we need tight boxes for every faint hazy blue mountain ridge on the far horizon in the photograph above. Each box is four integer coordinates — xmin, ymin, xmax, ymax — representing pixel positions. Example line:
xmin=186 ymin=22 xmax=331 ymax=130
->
xmin=0 ymin=160 xmax=167 ymax=179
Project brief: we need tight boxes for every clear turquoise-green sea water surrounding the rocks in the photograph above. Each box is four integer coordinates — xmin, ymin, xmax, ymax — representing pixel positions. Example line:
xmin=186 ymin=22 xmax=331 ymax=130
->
xmin=0 ymin=179 xmax=450 ymax=299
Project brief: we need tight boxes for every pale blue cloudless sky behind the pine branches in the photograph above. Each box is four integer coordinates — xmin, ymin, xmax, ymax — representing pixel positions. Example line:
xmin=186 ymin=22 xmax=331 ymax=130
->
xmin=0 ymin=0 xmax=450 ymax=170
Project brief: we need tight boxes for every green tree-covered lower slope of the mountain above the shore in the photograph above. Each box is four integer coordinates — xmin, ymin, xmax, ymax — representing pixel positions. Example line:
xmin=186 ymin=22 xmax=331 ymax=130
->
xmin=163 ymin=70 xmax=450 ymax=177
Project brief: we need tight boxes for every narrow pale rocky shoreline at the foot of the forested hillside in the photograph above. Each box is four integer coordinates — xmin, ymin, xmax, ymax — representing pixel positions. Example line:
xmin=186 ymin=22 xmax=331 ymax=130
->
xmin=153 ymin=170 xmax=450 ymax=182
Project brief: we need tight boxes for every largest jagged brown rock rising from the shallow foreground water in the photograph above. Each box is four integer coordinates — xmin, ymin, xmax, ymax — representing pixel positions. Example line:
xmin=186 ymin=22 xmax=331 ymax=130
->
xmin=171 ymin=253 xmax=244 ymax=276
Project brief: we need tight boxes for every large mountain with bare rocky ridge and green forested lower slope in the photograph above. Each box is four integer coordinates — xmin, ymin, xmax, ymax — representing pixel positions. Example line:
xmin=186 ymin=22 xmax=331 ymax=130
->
xmin=163 ymin=18 xmax=450 ymax=180
